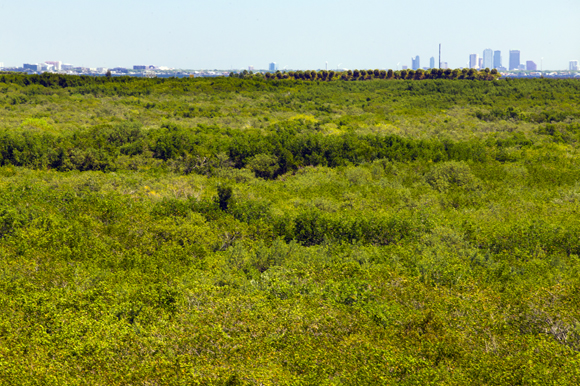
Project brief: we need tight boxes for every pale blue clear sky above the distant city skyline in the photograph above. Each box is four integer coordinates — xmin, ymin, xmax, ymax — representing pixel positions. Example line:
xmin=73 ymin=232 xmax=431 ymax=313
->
xmin=0 ymin=0 xmax=580 ymax=70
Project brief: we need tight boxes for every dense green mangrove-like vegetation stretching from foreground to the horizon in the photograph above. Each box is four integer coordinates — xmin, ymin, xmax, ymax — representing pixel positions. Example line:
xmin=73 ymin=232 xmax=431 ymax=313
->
xmin=0 ymin=71 xmax=580 ymax=385
